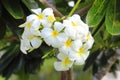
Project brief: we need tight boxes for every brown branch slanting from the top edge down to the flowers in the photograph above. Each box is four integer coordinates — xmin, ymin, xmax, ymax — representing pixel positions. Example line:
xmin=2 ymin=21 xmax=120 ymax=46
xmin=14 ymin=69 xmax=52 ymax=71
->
xmin=39 ymin=0 xmax=63 ymax=17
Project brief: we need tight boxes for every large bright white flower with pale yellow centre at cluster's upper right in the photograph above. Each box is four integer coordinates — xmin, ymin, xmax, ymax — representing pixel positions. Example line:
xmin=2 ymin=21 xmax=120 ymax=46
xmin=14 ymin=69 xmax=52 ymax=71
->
xmin=63 ymin=14 xmax=89 ymax=39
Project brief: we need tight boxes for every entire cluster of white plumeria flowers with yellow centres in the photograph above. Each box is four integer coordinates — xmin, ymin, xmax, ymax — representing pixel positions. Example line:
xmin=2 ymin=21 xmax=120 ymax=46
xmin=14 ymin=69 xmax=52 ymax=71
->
xmin=19 ymin=8 xmax=94 ymax=71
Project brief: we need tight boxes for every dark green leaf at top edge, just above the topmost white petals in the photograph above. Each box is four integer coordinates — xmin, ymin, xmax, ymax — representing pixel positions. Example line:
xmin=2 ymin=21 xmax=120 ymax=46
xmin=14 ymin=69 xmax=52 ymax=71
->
xmin=22 ymin=0 xmax=39 ymax=10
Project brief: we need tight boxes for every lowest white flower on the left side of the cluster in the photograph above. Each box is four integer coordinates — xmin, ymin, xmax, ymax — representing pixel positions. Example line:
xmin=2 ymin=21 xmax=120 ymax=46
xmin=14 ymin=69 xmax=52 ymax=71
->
xmin=20 ymin=31 xmax=42 ymax=54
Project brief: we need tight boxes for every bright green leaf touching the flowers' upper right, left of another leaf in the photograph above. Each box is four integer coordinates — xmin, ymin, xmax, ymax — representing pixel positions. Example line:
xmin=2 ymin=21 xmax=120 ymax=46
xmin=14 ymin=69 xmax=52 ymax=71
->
xmin=86 ymin=0 xmax=109 ymax=27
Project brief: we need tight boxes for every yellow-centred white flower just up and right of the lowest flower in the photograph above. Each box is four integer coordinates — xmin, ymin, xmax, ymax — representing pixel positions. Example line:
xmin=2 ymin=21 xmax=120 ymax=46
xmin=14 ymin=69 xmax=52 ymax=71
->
xmin=69 ymin=46 xmax=89 ymax=65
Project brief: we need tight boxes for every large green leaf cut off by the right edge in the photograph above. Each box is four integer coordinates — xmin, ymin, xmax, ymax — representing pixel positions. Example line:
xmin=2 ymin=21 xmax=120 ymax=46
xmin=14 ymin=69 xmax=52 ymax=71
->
xmin=105 ymin=0 xmax=120 ymax=35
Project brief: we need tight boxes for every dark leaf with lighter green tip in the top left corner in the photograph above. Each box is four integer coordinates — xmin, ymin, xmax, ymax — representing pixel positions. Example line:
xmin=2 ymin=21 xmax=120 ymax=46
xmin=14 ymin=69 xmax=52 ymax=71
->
xmin=1 ymin=0 xmax=24 ymax=19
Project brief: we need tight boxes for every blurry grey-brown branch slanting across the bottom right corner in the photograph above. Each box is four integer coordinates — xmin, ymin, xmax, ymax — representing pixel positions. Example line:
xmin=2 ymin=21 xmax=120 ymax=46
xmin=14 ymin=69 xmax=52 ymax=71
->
xmin=93 ymin=53 xmax=120 ymax=80
